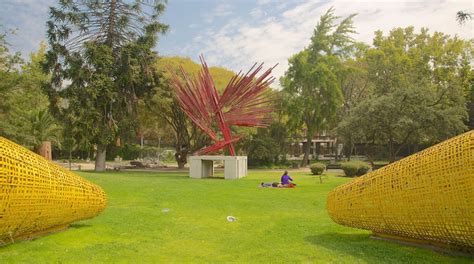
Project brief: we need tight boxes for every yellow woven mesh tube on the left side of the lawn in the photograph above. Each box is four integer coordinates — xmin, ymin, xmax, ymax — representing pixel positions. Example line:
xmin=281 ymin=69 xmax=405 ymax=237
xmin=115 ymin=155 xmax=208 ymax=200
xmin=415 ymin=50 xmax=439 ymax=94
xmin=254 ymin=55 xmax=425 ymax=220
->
xmin=0 ymin=137 xmax=106 ymax=243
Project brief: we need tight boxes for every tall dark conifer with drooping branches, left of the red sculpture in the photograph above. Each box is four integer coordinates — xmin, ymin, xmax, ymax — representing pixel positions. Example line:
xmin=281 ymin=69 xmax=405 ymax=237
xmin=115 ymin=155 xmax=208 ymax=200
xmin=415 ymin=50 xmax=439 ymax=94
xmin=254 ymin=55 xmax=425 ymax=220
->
xmin=44 ymin=0 xmax=167 ymax=171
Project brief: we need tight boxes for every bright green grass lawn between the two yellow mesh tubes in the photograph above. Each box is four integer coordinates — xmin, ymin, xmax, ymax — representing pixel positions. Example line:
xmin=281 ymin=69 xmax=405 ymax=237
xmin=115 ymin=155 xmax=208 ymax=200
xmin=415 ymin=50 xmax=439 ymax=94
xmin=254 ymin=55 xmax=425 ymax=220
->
xmin=0 ymin=171 xmax=472 ymax=263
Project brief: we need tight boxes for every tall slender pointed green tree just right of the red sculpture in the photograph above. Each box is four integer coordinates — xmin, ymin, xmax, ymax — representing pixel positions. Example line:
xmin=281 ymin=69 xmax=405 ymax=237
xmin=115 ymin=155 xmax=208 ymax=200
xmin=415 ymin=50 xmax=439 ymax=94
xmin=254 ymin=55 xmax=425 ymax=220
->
xmin=281 ymin=8 xmax=355 ymax=165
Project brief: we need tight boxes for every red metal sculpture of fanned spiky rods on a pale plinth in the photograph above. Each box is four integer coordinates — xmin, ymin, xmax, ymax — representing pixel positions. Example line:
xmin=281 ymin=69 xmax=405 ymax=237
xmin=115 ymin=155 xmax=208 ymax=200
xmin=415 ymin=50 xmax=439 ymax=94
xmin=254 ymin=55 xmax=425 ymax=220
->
xmin=172 ymin=56 xmax=276 ymax=156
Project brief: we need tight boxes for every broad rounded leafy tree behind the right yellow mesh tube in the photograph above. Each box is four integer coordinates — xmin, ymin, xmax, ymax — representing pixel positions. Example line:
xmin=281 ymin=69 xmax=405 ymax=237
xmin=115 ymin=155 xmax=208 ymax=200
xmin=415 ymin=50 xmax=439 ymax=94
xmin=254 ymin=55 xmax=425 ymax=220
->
xmin=340 ymin=27 xmax=473 ymax=161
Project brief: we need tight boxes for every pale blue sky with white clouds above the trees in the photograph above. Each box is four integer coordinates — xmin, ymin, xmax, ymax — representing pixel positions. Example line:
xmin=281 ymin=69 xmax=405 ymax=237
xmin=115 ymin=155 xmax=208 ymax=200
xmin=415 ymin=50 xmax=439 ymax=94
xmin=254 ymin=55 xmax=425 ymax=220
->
xmin=0 ymin=0 xmax=474 ymax=78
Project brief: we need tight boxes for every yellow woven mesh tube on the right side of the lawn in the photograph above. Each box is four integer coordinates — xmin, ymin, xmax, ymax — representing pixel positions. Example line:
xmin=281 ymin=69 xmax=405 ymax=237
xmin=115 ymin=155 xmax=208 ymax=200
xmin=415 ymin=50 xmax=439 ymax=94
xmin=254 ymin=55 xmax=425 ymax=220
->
xmin=327 ymin=130 xmax=474 ymax=252
